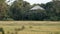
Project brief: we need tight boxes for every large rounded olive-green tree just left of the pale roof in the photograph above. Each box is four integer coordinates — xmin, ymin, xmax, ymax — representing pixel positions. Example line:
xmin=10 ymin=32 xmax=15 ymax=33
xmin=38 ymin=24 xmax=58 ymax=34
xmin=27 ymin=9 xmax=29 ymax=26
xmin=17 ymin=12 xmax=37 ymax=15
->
xmin=10 ymin=0 xmax=30 ymax=20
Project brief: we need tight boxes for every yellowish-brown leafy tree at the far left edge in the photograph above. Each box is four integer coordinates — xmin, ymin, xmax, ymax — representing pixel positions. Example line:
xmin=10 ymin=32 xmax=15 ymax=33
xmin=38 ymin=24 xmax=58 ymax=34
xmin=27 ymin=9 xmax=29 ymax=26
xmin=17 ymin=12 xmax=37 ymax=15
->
xmin=0 ymin=0 xmax=8 ymax=20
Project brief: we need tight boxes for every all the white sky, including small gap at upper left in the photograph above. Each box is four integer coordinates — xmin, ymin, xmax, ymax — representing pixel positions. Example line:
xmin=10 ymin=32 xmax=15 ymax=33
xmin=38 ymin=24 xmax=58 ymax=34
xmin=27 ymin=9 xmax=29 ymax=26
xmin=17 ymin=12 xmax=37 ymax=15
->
xmin=7 ymin=0 xmax=52 ymax=5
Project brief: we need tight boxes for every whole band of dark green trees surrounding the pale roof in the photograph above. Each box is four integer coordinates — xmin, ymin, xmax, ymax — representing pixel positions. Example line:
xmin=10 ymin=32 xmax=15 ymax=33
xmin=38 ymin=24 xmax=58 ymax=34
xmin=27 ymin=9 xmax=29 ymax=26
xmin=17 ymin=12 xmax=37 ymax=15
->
xmin=0 ymin=0 xmax=60 ymax=21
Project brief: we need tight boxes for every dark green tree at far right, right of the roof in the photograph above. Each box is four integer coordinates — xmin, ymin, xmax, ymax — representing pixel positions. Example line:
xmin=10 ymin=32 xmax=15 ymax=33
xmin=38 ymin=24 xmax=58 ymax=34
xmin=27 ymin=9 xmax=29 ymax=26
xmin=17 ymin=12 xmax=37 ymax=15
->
xmin=44 ymin=1 xmax=60 ymax=21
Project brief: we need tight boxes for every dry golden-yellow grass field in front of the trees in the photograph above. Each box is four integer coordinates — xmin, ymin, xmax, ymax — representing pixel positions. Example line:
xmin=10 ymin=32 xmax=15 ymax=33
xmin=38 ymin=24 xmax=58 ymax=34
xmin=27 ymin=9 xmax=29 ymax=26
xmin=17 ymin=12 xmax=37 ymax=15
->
xmin=0 ymin=21 xmax=60 ymax=34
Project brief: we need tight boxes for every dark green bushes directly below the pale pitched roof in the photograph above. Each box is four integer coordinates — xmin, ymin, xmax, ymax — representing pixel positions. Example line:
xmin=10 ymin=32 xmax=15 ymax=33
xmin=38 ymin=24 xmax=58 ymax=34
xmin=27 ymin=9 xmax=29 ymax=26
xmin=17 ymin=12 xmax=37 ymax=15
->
xmin=24 ymin=10 xmax=45 ymax=20
